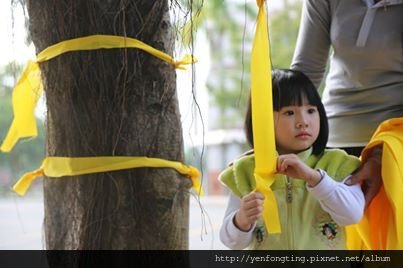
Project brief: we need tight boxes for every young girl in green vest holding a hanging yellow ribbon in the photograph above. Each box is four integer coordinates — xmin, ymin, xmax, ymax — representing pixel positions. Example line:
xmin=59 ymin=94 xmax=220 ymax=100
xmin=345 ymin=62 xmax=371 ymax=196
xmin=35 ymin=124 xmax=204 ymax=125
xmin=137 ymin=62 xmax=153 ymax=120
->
xmin=220 ymin=70 xmax=365 ymax=250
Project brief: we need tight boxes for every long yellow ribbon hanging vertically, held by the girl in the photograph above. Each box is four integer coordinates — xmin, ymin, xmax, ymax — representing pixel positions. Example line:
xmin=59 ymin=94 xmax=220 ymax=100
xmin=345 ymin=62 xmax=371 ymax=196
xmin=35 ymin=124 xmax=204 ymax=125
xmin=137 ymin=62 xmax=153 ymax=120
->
xmin=251 ymin=0 xmax=281 ymax=233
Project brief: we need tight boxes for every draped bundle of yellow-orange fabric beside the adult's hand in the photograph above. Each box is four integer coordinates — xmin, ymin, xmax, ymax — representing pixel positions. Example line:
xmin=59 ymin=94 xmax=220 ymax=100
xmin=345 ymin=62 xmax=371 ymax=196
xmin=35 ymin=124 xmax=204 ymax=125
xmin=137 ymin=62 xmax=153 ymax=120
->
xmin=346 ymin=117 xmax=403 ymax=250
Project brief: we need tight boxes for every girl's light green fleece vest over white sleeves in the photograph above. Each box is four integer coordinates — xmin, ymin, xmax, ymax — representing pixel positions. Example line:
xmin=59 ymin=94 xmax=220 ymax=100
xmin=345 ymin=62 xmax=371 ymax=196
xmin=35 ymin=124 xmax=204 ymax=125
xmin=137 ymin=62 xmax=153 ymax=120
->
xmin=219 ymin=149 xmax=360 ymax=250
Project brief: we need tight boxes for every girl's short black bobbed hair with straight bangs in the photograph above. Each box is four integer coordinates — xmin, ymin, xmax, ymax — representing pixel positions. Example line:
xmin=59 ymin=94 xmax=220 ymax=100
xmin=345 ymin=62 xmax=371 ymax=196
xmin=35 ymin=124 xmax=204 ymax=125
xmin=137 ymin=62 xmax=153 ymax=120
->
xmin=245 ymin=69 xmax=329 ymax=155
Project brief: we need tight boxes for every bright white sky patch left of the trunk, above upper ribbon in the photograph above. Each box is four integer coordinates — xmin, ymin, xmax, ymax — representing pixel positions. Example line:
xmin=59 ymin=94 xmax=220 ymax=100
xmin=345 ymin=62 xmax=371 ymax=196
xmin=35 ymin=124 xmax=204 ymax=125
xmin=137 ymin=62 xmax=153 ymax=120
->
xmin=0 ymin=0 xmax=35 ymax=65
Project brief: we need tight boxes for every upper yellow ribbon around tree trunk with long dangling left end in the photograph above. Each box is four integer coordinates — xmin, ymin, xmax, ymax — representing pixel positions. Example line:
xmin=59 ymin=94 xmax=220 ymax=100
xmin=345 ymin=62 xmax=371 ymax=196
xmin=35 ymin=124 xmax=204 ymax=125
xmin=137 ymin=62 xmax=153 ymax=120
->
xmin=0 ymin=35 xmax=196 ymax=152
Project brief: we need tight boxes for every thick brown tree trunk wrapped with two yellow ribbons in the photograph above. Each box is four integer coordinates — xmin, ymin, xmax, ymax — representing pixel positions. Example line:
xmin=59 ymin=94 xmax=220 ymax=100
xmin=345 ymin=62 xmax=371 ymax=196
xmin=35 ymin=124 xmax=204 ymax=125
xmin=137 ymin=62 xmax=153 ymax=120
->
xmin=27 ymin=0 xmax=191 ymax=249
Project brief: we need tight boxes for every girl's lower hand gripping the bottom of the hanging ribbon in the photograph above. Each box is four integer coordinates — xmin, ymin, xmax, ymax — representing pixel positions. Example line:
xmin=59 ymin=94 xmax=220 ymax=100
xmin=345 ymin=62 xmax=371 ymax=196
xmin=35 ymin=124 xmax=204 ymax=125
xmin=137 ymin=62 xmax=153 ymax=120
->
xmin=234 ymin=192 xmax=264 ymax=232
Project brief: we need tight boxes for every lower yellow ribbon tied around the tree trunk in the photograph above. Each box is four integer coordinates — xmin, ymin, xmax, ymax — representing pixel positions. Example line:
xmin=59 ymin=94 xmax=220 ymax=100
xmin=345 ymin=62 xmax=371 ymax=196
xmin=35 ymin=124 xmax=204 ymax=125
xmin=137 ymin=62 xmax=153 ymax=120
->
xmin=13 ymin=156 xmax=202 ymax=196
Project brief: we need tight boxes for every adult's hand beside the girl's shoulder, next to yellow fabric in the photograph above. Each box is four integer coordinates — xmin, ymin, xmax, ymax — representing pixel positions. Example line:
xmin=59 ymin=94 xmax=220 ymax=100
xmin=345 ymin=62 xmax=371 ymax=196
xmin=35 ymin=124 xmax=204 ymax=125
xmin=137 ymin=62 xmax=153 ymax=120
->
xmin=349 ymin=146 xmax=382 ymax=207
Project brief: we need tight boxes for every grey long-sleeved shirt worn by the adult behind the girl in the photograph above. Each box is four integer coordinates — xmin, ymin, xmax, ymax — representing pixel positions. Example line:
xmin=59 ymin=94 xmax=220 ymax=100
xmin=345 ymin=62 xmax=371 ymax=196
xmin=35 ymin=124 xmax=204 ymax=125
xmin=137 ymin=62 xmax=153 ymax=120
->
xmin=291 ymin=0 xmax=403 ymax=147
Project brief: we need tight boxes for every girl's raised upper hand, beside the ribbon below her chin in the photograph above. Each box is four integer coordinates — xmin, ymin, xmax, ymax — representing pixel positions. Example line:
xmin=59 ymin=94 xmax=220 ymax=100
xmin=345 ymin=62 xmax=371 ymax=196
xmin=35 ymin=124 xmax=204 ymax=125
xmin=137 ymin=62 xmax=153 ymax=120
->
xmin=277 ymin=154 xmax=322 ymax=187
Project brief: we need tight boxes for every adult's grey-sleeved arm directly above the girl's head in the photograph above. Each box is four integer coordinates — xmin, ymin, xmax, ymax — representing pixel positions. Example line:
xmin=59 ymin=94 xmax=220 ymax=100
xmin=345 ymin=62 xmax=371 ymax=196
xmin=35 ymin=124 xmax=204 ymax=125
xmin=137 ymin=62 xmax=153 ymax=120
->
xmin=291 ymin=0 xmax=332 ymax=88
